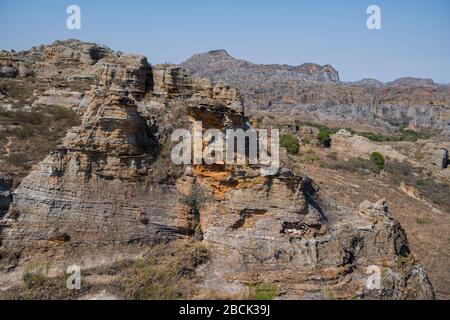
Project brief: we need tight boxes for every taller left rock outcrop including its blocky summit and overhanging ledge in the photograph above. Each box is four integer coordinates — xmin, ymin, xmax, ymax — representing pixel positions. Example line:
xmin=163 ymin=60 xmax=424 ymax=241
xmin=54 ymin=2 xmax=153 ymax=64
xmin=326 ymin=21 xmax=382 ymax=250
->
xmin=2 ymin=55 xmax=243 ymax=256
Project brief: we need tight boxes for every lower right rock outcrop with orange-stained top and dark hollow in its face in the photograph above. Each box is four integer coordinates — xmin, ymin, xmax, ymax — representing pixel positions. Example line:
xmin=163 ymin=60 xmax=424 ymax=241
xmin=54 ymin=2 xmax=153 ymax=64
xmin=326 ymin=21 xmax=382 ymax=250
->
xmin=196 ymin=161 xmax=434 ymax=299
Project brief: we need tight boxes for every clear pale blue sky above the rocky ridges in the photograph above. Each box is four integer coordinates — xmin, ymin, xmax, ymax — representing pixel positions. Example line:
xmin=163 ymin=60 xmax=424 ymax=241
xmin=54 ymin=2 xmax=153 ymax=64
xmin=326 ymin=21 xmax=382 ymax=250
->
xmin=0 ymin=0 xmax=450 ymax=83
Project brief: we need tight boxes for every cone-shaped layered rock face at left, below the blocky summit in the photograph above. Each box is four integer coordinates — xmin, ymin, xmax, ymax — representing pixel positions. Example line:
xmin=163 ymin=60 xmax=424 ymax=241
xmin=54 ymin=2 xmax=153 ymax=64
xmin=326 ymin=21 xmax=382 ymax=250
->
xmin=3 ymin=93 xmax=181 ymax=247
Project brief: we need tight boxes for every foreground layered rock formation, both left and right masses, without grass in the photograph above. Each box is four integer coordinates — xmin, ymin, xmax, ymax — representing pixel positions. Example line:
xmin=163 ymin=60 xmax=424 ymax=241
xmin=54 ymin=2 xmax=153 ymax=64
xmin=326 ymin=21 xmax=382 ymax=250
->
xmin=1 ymin=43 xmax=434 ymax=299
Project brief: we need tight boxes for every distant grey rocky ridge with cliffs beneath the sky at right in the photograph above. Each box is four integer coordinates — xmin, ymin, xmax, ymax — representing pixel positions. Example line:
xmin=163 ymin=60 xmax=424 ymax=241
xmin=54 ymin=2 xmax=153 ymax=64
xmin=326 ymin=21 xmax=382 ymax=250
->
xmin=181 ymin=50 xmax=450 ymax=135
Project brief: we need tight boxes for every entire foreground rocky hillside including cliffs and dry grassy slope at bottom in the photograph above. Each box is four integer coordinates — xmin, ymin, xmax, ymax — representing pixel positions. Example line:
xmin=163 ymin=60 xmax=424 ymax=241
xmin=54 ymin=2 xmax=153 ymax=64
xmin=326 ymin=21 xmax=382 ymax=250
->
xmin=0 ymin=40 xmax=442 ymax=299
